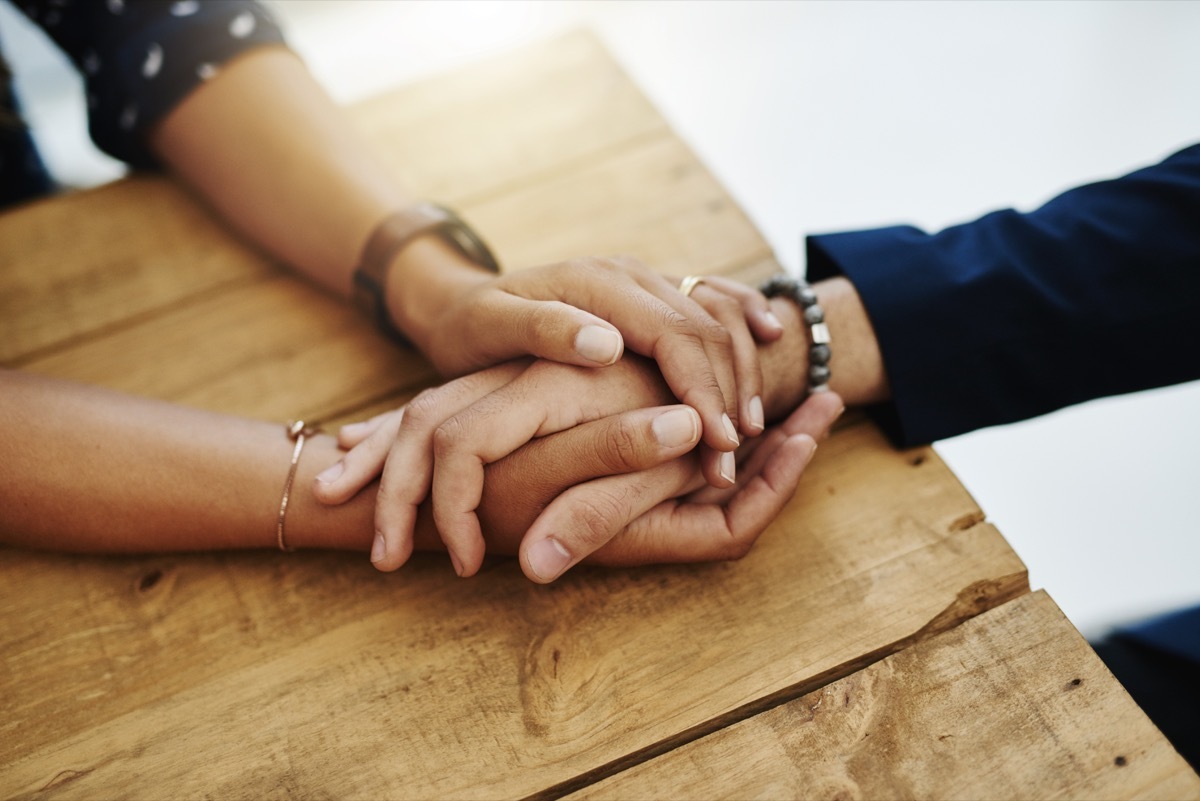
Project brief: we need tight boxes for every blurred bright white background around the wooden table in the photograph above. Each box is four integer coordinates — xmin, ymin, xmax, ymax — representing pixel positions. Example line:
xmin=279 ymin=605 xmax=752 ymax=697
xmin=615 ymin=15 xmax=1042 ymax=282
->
xmin=0 ymin=0 xmax=1200 ymax=637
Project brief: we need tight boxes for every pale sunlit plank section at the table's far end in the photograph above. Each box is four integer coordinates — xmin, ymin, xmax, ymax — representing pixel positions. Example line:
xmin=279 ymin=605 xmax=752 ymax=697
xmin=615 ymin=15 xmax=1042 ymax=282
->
xmin=353 ymin=31 xmax=667 ymax=204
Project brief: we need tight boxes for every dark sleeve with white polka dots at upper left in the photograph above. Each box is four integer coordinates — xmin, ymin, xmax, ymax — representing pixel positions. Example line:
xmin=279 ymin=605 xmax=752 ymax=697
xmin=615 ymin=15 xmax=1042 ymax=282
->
xmin=18 ymin=0 xmax=283 ymax=167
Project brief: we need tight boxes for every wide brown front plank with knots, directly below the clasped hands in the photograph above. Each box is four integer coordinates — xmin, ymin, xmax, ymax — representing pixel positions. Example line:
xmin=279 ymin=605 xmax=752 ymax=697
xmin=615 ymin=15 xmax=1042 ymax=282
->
xmin=0 ymin=423 xmax=1027 ymax=797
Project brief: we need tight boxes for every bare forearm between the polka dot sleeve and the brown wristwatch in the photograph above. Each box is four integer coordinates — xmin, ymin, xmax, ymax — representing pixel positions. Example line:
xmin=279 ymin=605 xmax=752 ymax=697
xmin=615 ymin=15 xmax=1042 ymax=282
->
xmin=150 ymin=47 xmax=478 ymax=303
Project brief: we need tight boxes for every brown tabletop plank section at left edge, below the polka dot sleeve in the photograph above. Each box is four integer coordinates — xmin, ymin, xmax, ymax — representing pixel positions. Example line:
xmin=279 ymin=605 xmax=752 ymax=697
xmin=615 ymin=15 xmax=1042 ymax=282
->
xmin=0 ymin=176 xmax=275 ymax=366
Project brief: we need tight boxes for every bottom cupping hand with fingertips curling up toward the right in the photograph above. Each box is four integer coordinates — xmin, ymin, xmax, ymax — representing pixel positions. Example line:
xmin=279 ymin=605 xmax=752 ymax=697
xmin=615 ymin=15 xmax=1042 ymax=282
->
xmin=340 ymin=392 xmax=841 ymax=583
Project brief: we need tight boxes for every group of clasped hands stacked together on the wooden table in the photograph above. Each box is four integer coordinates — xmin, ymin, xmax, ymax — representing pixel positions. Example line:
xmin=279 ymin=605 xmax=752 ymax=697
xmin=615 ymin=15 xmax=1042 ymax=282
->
xmin=316 ymin=259 xmax=841 ymax=582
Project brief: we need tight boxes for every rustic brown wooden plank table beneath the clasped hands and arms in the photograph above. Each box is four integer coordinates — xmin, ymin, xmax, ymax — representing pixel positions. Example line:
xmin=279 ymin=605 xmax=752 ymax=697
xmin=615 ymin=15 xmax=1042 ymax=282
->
xmin=0 ymin=32 xmax=1200 ymax=799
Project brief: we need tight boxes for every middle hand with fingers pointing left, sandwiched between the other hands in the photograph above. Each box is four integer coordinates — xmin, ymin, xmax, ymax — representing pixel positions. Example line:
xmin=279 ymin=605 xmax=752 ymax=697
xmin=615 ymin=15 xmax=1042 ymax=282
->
xmin=313 ymin=356 xmax=681 ymax=576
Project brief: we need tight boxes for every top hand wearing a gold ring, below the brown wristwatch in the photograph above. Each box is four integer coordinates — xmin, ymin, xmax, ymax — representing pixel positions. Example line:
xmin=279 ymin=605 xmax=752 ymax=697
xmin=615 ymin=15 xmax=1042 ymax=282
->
xmin=415 ymin=257 xmax=764 ymax=455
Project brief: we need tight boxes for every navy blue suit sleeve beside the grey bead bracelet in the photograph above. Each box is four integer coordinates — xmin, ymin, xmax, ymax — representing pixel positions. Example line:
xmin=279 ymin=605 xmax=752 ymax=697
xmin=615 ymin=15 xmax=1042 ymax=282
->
xmin=806 ymin=145 xmax=1200 ymax=445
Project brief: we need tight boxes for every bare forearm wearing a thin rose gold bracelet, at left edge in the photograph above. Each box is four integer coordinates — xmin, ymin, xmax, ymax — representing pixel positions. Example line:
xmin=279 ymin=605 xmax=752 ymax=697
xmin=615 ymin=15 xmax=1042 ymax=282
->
xmin=0 ymin=371 xmax=374 ymax=553
